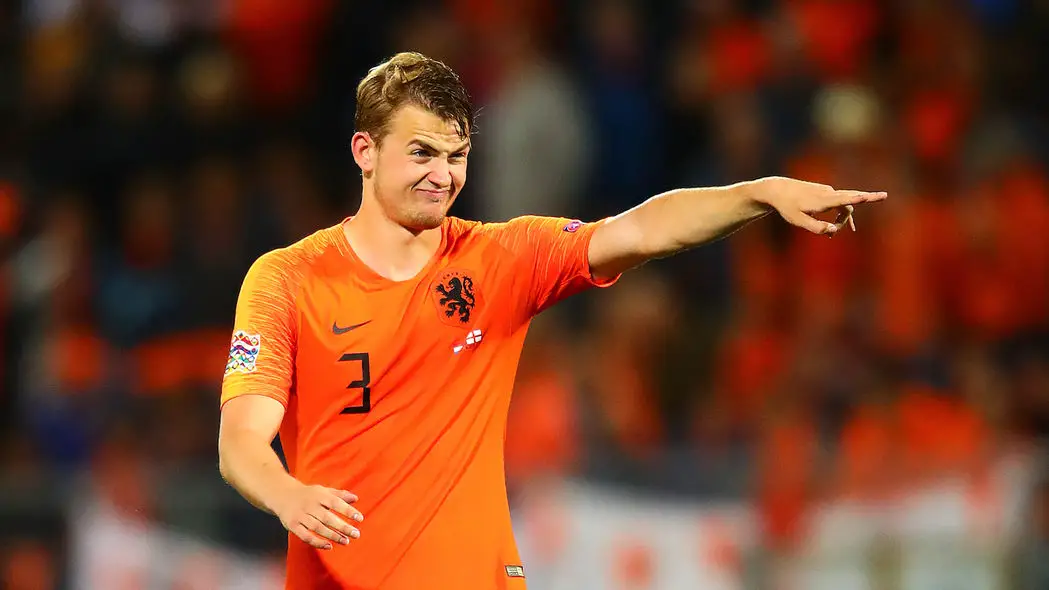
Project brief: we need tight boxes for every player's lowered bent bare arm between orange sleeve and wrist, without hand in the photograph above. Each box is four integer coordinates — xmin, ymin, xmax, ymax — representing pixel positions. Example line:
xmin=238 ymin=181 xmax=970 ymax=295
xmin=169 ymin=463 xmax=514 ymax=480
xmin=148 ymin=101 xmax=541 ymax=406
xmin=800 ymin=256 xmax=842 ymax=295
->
xmin=218 ymin=395 xmax=301 ymax=514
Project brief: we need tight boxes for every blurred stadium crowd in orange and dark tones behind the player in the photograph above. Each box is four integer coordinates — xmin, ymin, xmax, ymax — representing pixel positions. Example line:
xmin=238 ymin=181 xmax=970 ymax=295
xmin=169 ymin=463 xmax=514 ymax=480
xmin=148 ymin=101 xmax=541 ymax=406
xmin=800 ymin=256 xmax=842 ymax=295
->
xmin=0 ymin=0 xmax=1049 ymax=590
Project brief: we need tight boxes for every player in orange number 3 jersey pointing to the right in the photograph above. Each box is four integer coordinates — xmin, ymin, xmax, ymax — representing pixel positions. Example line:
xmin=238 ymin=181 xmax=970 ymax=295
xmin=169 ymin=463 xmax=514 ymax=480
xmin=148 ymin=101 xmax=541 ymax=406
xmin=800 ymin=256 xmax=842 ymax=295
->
xmin=219 ymin=54 xmax=885 ymax=590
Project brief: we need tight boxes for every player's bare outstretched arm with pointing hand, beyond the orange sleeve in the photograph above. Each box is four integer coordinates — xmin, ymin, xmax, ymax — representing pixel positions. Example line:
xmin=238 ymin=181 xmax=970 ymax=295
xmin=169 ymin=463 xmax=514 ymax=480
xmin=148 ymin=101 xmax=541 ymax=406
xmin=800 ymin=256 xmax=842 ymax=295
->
xmin=587 ymin=176 xmax=887 ymax=279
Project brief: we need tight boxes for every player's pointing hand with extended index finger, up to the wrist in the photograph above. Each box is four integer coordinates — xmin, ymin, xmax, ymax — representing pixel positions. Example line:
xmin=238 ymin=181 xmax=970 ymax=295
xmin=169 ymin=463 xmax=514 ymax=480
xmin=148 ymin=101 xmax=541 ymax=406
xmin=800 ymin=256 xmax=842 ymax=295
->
xmin=755 ymin=176 xmax=889 ymax=236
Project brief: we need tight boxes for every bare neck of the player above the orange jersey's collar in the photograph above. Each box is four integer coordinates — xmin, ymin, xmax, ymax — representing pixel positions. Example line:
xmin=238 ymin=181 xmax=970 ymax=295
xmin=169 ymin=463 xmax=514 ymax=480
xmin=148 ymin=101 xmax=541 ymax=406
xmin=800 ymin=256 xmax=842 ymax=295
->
xmin=343 ymin=190 xmax=441 ymax=281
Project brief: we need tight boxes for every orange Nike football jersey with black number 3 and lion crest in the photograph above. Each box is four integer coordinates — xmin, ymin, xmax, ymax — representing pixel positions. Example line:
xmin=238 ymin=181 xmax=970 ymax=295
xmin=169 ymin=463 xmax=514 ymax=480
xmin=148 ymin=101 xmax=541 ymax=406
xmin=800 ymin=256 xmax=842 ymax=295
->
xmin=222 ymin=216 xmax=613 ymax=590
